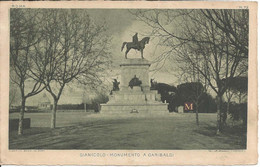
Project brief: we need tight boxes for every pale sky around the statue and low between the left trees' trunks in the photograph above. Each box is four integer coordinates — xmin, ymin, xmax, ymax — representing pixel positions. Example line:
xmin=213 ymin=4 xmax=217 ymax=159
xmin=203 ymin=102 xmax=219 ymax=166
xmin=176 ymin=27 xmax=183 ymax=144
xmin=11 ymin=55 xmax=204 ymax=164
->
xmin=11 ymin=9 xmax=179 ymax=105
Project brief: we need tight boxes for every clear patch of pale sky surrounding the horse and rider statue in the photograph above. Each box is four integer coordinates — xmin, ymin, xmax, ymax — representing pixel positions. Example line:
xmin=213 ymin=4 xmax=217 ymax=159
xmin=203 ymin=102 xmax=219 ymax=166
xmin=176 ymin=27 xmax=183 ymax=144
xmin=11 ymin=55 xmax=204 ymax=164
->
xmin=88 ymin=9 xmax=178 ymax=86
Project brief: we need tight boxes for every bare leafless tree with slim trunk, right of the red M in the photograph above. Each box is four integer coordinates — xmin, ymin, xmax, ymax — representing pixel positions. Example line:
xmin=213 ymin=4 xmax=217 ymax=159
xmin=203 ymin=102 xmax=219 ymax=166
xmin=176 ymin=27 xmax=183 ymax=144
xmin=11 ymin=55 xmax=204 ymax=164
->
xmin=174 ymin=10 xmax=248 ymax=133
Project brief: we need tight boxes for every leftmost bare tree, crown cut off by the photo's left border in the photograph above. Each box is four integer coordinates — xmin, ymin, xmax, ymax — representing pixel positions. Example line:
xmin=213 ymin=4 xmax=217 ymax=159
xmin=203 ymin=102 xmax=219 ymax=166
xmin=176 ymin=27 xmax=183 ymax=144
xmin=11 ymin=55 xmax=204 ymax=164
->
xmin=10 ymin=9 xmax=45 ymax=135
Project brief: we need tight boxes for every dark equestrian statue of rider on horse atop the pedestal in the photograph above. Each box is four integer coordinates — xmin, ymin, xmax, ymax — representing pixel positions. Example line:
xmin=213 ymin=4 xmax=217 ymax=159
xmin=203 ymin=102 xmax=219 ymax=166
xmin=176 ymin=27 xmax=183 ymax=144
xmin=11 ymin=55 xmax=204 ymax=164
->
xmin=121 ymin=33 xmax=150 ymax=59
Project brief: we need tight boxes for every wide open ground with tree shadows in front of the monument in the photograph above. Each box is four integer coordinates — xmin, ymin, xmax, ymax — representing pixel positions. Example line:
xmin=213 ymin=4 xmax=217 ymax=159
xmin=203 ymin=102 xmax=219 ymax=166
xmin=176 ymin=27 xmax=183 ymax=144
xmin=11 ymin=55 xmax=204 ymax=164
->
xmin=9 ymin=112 xmax=246 ymax=150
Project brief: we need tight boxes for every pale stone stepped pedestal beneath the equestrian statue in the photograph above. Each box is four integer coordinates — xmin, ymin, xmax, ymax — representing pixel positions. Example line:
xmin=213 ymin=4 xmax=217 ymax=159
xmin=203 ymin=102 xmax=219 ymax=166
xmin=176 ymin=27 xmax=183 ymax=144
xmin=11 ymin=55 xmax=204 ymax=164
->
xmin=101 ymin=59 xmax=169 ymax=114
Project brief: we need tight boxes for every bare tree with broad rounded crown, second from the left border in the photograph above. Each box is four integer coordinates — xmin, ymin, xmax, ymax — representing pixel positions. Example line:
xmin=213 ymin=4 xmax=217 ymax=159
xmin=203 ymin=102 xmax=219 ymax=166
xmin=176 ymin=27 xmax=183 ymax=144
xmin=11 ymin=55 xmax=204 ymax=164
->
xmin=35 ymin=9 xmax=110 ymax=128
